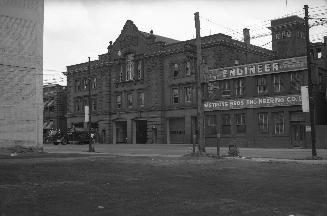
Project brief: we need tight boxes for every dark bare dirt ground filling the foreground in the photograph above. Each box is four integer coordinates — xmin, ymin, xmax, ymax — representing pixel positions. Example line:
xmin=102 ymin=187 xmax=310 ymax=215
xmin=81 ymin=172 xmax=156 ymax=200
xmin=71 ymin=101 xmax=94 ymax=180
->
xmin=0 ymin=154 xmax=327 ymax=216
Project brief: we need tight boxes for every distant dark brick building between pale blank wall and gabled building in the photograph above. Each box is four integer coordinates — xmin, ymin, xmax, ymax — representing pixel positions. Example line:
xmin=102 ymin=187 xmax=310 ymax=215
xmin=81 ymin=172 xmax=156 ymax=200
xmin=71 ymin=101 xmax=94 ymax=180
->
xmin=43 ymin=84 xmax=67 ymax=134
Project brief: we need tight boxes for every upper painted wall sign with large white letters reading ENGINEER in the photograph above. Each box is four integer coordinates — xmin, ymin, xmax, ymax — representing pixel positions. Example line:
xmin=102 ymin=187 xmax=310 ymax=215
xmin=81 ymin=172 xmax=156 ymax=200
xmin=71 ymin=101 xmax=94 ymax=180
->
xmin=205 ymin=56 xmax=307 ymax=82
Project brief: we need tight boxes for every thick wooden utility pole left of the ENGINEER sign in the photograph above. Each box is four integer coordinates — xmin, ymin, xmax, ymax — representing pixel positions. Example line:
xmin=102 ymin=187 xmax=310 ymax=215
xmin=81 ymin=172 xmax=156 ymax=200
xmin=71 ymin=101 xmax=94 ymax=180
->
xmin=194 ymin=12 xmax=205 ymax=153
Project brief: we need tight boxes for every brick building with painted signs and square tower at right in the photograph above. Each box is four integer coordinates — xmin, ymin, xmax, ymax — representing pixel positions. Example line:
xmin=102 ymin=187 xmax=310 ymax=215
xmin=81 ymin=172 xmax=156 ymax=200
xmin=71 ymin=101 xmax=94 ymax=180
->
xmin=205 ymin=16 xmax=327 ymax=148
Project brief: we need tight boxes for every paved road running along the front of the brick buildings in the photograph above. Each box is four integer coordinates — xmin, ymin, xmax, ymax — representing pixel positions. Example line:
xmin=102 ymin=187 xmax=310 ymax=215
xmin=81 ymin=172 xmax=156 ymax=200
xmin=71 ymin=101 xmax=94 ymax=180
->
xmin=44 ymin=144 xmax=327 ymax=159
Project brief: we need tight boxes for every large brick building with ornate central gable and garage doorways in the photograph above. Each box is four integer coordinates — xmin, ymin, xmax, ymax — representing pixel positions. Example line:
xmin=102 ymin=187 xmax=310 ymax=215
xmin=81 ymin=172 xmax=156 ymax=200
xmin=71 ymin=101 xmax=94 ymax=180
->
xmin=67 ymin=15 xmax=326 ymax=147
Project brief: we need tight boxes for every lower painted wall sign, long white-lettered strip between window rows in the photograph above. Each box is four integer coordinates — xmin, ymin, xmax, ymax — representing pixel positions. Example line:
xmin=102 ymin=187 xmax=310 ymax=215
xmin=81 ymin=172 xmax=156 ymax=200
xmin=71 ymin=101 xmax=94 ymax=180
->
xmin=204 ymin=95 xmax=302 ymax=111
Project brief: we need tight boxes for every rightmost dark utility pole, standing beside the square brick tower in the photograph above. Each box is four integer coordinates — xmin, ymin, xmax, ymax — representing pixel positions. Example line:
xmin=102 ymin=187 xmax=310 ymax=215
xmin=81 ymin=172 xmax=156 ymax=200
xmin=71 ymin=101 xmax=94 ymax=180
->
xmin=304 ymin=5 xmax=317 ymax=157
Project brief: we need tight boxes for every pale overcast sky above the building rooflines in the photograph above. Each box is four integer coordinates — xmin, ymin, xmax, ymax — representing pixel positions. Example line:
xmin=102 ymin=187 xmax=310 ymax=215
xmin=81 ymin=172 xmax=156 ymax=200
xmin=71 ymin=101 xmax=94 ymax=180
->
xmin=43 ymin=0 xmax=327 ymax=85
